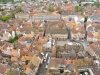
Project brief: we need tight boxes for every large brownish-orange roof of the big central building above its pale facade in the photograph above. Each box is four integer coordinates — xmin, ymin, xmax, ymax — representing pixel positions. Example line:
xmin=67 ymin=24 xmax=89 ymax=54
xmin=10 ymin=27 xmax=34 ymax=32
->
xmin=47 ymin=21 xmax=67 ymax=34
